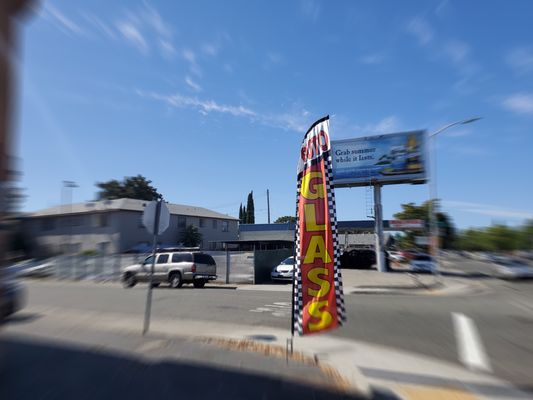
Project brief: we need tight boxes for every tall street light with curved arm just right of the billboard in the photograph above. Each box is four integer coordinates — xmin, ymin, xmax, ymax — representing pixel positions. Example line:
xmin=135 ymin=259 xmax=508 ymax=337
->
xmin=429 ymin=117 xmax=482 ymax=270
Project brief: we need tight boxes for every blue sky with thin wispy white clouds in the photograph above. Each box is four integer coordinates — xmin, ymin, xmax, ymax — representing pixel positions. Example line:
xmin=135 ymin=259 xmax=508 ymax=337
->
xmin=12 ymin=0 xmax=533 ymax=227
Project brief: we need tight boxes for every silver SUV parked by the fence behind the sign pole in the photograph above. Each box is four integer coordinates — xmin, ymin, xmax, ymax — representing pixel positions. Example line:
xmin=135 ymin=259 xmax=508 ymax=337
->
xmin=122 ymin=251 xmax=217 ymax=288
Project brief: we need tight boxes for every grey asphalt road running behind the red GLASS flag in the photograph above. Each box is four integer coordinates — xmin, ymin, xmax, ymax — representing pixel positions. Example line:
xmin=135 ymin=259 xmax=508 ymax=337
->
xmin=9 ymin=255 xmax=533 ymax=390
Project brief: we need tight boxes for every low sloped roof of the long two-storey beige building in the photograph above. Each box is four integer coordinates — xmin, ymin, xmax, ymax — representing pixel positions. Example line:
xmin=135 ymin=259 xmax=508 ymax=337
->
xmin=25 ymin=199 xmax=239 ymax=221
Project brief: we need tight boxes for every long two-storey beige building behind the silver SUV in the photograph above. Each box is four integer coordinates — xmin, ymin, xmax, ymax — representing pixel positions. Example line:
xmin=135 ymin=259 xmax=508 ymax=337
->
xmin=22 ymin=199 xmax=238 ymax=255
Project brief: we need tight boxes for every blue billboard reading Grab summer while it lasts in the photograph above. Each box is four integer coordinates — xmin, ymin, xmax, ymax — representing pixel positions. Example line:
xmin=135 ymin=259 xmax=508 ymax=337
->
xmin=331 ymin=131 xmax=427 ymax=187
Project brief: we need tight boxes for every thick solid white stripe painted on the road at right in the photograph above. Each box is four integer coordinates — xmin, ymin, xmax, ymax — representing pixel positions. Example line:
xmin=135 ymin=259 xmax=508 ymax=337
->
xmin=452 ymin=313 xmax=492 ymax=372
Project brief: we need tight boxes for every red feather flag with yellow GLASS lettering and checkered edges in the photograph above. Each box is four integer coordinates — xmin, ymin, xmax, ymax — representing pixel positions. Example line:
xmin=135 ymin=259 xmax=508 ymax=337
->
xmin=292 ymin=117 xmax=346 ymax=335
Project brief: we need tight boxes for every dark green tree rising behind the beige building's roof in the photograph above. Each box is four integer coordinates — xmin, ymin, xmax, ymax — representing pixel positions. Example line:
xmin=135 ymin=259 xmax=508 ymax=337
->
xmin=96 ymin=175 xmax=163 ymax=201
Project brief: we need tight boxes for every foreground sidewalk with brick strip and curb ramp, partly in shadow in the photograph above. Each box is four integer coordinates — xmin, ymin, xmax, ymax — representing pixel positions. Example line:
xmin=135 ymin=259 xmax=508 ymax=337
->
xmin=0 ymin=307 xmax=531 ymax=400
